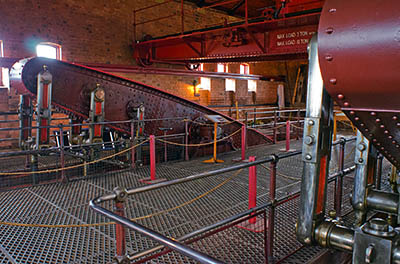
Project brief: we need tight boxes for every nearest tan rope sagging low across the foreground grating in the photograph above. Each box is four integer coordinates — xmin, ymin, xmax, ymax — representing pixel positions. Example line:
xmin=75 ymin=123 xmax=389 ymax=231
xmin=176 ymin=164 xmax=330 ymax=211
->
xmin=0 ymin=169 xmax=243 ymax=228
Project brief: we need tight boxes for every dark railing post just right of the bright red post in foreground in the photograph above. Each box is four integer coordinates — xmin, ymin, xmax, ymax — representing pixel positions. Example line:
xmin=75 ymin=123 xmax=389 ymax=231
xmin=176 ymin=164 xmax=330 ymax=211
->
xmin=267 ymin=155 xmax=278 ymax=263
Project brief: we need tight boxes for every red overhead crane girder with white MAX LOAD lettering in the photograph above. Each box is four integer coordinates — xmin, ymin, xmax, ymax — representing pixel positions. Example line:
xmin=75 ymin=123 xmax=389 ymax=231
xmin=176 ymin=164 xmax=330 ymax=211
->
xmin=133 ymin=0 xmax=324 ymax=66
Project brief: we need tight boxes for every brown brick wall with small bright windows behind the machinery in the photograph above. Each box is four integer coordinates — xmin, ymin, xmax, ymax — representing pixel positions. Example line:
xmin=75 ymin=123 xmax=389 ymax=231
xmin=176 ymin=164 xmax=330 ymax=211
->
xmin=0 ymin=0 xmax=296 ymax=147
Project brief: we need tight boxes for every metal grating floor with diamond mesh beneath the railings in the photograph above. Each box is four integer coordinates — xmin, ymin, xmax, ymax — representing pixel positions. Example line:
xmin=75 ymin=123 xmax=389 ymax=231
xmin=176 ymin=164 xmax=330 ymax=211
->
xmin=0 ymin=138 xmax=388 ymax=264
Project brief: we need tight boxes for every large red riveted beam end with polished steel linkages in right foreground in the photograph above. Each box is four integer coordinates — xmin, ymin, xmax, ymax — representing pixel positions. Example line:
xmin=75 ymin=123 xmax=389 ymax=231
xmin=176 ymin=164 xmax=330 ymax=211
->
xmin=296 ymin=0 xmax=400 ymax=264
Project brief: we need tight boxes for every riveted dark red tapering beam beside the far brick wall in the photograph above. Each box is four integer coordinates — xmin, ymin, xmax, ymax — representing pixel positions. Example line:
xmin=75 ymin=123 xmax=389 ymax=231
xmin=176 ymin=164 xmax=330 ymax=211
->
xmin=11 ymin=58 xmax=271 ymax=153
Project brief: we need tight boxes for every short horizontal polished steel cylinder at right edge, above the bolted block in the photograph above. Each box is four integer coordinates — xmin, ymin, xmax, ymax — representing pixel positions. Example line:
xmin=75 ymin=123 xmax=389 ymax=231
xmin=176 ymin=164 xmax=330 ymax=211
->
xmin=367 ymin=190 xmax=399 ymax=215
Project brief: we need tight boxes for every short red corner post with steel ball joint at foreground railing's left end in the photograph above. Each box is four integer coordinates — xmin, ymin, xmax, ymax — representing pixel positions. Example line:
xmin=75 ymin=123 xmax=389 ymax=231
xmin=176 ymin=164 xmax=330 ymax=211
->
xmin=114 ymin=187 xmax=129 ymax=263
